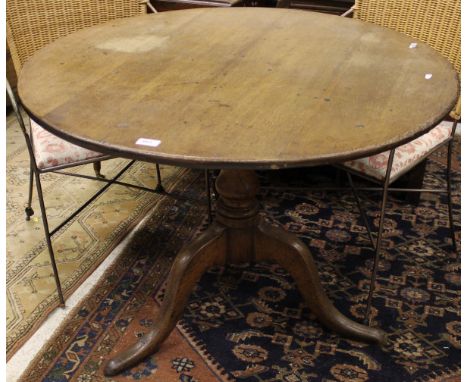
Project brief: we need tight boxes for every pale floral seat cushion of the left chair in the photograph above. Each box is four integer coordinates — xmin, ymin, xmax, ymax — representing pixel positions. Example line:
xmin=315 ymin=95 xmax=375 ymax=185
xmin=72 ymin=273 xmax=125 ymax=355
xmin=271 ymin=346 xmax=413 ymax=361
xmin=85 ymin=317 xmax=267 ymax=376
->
xmin=30 ymin=120 xmax=104 ymax=170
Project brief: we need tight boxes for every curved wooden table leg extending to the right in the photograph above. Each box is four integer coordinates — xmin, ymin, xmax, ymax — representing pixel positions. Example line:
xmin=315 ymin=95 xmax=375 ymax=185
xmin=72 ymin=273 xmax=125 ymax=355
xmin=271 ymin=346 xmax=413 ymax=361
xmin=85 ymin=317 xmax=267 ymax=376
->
xmin=255 ymin=221 xmax=386 ymax=344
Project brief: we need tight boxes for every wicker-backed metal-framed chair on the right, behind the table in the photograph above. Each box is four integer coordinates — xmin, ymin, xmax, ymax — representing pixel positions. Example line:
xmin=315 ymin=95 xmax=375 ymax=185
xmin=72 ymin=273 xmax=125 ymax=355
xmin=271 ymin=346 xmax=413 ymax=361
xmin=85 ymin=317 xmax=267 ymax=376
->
xmin=336 ymin=0 xmax=461 ymax=320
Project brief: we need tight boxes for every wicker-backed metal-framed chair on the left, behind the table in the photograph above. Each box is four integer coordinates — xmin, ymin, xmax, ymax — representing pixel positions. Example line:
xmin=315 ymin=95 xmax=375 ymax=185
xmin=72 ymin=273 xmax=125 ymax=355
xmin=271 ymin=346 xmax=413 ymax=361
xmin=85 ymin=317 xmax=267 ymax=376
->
xmin=6 ymin=0 xmax=164 ymax=305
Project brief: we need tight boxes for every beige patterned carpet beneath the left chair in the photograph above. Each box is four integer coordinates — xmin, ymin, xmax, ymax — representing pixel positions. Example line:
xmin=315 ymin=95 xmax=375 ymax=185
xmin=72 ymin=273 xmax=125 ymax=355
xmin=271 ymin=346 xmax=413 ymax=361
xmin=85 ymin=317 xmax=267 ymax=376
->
xmin=6 ymin=114 xmax=184 ymax=359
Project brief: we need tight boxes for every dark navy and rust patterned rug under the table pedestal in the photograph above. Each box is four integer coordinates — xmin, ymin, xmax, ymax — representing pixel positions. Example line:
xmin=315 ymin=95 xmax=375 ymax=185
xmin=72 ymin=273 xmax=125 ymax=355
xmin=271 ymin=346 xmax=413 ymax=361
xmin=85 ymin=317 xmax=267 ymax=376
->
xmin=21 ymin=142 xmax=461 ymax=382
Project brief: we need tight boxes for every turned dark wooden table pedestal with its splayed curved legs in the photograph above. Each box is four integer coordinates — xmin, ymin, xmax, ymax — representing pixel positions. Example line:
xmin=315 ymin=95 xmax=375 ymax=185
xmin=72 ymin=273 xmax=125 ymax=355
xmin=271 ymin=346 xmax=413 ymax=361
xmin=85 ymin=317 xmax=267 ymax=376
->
xmin=104 ymin=170 xmax=385 ymax=376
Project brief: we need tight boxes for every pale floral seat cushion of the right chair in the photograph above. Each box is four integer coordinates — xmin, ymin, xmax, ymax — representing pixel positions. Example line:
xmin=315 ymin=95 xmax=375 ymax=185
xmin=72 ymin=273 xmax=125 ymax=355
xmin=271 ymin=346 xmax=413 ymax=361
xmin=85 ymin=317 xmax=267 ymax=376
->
xmin=344 ymin=122 xmax=452 ymax=182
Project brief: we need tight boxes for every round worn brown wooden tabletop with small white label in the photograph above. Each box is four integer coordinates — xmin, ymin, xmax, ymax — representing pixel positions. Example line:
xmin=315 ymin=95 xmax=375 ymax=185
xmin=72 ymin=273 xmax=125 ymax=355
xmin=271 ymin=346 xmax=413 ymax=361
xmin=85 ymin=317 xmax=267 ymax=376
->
xmin=18 ymin=8 xmax=459 ymax=169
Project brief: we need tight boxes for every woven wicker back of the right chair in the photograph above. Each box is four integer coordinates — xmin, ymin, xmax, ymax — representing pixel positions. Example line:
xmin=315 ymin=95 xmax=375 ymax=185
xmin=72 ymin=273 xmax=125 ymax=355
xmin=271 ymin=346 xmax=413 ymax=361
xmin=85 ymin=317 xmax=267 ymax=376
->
xmin=354 ymin=0 xmax=461 ymax=118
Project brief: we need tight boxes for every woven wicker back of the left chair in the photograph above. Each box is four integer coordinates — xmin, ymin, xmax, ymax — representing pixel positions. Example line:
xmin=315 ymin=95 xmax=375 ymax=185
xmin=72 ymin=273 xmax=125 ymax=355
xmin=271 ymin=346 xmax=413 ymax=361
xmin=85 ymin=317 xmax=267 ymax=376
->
xmin=6 ymin=0 xmax=146 ymax=73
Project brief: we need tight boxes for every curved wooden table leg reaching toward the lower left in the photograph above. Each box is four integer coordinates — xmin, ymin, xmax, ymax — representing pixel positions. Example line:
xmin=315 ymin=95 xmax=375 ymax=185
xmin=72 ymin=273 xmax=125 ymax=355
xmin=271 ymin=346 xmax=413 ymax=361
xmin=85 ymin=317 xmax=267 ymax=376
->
xmin=104 ymin=224 xmax=226 ymax=376
